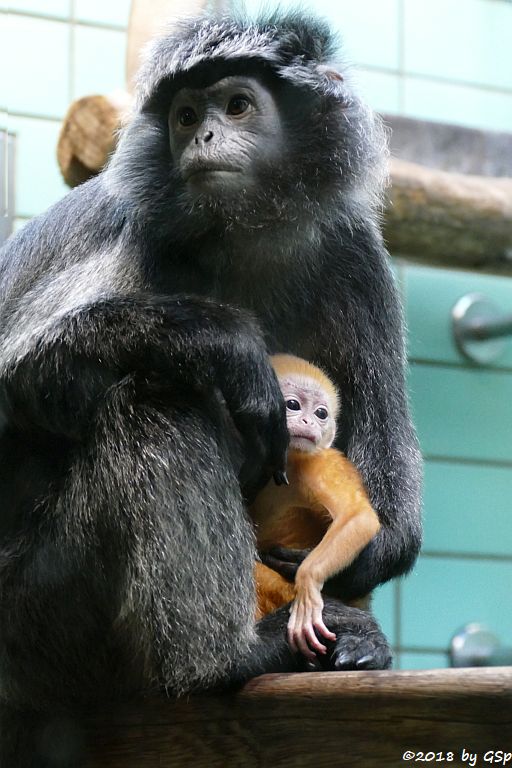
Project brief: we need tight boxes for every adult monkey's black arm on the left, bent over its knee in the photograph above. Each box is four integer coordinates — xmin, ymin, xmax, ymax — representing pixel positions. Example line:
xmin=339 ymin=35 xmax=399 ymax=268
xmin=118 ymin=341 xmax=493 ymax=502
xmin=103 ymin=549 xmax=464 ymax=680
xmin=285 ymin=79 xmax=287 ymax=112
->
xmin=0 ymin=288 xmax=287 ymax=490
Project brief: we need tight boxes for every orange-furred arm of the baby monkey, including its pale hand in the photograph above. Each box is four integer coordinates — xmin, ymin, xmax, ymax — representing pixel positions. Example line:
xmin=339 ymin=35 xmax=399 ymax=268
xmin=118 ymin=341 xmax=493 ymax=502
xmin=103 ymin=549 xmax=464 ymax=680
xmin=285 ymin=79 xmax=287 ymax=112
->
xmin=288 ymin=449 xmax=380 ymax=658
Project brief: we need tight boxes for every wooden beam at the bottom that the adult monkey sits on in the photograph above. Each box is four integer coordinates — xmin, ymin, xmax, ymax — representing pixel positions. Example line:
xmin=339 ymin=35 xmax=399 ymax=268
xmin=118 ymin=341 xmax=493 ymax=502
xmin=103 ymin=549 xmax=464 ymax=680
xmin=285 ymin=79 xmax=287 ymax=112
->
xmin=76 ymin=667 xmax=512 ymax=768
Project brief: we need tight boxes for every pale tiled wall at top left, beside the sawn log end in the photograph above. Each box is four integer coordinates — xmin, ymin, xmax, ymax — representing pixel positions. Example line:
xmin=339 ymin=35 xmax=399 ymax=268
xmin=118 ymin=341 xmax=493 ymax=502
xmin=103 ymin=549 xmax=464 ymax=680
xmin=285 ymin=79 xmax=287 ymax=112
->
xmin=0 ymin=0 xmax=130 ymax=228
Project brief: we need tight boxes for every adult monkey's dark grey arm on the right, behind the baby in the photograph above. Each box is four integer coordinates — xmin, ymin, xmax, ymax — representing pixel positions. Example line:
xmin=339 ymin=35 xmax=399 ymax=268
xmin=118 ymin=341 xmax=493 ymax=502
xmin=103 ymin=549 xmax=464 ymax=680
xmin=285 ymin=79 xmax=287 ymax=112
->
xmin=318 ymin=230 xmax=421 ymax=600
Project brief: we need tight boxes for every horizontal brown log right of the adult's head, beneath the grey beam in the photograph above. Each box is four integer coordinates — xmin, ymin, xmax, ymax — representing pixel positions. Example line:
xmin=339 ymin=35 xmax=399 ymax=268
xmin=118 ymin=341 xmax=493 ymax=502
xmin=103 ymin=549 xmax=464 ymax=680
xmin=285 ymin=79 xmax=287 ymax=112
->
xmin=384 ymin=159 xmax=512 ymax=271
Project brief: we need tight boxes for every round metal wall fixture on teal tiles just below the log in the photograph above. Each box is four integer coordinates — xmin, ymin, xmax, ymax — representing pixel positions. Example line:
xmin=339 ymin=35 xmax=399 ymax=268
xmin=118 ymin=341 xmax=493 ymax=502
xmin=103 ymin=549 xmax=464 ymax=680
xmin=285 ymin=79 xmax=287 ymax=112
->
xmin=452 ymin=293 xmax=512 ymax=365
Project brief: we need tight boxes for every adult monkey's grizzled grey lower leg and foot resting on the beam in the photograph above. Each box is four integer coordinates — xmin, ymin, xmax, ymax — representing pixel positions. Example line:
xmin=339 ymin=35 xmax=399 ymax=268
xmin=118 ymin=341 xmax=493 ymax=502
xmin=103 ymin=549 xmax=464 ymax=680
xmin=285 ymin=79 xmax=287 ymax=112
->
xmin=123 ymin=390 xmax=390 ymax=692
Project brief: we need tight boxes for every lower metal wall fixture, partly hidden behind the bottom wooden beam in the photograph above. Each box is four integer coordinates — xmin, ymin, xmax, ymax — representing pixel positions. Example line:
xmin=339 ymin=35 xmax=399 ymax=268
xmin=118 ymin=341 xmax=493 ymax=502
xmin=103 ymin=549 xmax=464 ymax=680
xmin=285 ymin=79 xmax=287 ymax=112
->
xmin=449 ymin=623 xmax=512 ymax=667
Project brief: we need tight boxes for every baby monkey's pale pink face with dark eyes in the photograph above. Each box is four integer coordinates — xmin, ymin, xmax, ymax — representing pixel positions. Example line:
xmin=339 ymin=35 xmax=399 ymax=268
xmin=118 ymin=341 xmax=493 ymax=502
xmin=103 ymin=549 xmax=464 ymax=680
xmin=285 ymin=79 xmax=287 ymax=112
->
xmin=279 ymin=376 xmax=336 ymax=453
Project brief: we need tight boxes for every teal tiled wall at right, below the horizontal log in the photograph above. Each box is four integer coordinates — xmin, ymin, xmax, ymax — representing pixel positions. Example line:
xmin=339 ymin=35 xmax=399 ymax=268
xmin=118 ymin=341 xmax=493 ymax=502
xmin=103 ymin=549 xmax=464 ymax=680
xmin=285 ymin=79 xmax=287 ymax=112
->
xmin=375 ymin=263 xmax=512 ymax=668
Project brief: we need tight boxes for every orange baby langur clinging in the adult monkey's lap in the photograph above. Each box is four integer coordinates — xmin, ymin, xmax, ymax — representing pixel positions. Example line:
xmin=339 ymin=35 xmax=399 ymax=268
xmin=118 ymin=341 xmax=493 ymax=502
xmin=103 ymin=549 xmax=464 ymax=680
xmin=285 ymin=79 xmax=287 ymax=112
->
xmin=250 ymin=355 xmax=380 ymax=659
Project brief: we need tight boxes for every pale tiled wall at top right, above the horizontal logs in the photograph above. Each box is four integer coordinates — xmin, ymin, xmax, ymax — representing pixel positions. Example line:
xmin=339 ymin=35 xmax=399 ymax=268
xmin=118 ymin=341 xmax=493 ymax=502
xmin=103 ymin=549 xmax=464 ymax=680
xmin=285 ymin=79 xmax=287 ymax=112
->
xmin=242 ymin=0 xmax=512 ymax=131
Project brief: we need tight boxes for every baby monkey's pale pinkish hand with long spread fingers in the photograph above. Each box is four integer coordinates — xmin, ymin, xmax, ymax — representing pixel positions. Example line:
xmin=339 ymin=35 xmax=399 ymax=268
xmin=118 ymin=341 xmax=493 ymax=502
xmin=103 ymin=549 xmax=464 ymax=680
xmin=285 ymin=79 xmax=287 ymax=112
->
xmin=287 ymin=573 xmax=336 ymax=661
